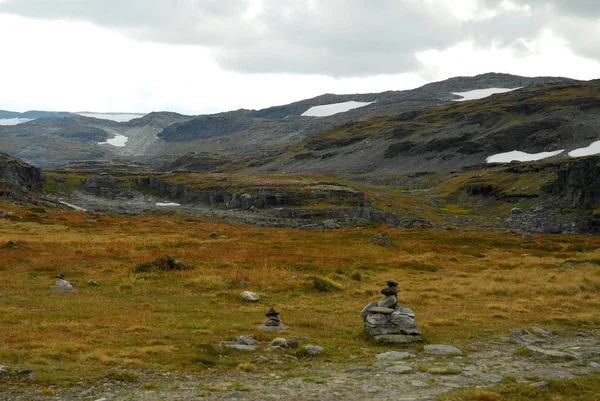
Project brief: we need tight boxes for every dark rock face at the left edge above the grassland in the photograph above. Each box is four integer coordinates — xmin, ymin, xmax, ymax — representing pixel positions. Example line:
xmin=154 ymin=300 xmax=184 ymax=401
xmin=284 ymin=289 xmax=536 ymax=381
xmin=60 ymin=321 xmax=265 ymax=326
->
xmin=0 ymin=152 xmax=44 ymax=199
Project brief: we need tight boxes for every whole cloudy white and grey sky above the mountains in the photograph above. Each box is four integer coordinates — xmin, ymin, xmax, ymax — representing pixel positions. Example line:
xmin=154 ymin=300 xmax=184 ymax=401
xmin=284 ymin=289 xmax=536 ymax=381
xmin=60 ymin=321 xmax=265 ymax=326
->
xmin=0 ymin=0 xmax=600 ymax=114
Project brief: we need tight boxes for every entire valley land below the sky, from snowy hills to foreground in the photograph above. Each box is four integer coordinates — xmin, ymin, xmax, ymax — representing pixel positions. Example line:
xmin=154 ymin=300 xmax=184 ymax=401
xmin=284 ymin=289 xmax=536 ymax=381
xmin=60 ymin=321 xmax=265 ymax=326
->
xmin=0 ymin=74 xmax=600 ymax=401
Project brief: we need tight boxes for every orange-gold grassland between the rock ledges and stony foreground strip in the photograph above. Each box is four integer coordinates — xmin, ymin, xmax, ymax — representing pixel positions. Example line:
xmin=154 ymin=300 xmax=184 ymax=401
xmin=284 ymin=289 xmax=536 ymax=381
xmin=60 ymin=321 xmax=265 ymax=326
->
xmin=0 ymin=203 xmax=600 ymax=399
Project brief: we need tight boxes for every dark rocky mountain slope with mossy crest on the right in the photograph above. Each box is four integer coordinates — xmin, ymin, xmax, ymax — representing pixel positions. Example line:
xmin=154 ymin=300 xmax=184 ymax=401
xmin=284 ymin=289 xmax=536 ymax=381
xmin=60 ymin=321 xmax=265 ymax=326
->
xmin=261 ymin=81 xmax=600 ymax=174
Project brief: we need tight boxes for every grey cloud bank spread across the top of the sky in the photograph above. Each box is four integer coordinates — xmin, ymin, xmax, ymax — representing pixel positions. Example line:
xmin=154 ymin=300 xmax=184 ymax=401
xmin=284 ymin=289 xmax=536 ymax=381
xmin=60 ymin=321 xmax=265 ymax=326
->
xmin=0 ymin=0 xmax=600 ymax=76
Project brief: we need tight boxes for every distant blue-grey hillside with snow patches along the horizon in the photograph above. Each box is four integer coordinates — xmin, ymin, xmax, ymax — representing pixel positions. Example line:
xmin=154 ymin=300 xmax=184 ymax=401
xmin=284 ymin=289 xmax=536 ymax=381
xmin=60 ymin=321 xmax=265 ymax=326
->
xmin=0 ymin=74 xmax=572 ymax=167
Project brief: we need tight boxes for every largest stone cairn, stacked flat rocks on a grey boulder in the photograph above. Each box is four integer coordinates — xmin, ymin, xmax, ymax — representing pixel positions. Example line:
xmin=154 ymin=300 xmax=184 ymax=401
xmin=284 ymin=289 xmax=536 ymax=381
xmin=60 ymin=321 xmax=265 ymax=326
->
xmin=360 ymin=280 xmax=423 ymax=343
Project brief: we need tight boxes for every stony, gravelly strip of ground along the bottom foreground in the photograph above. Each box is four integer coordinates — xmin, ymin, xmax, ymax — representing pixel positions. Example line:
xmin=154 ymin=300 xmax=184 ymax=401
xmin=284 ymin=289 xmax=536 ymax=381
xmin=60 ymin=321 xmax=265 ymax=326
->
xmin=0 ymin=327 xmax=600 ymax=401
